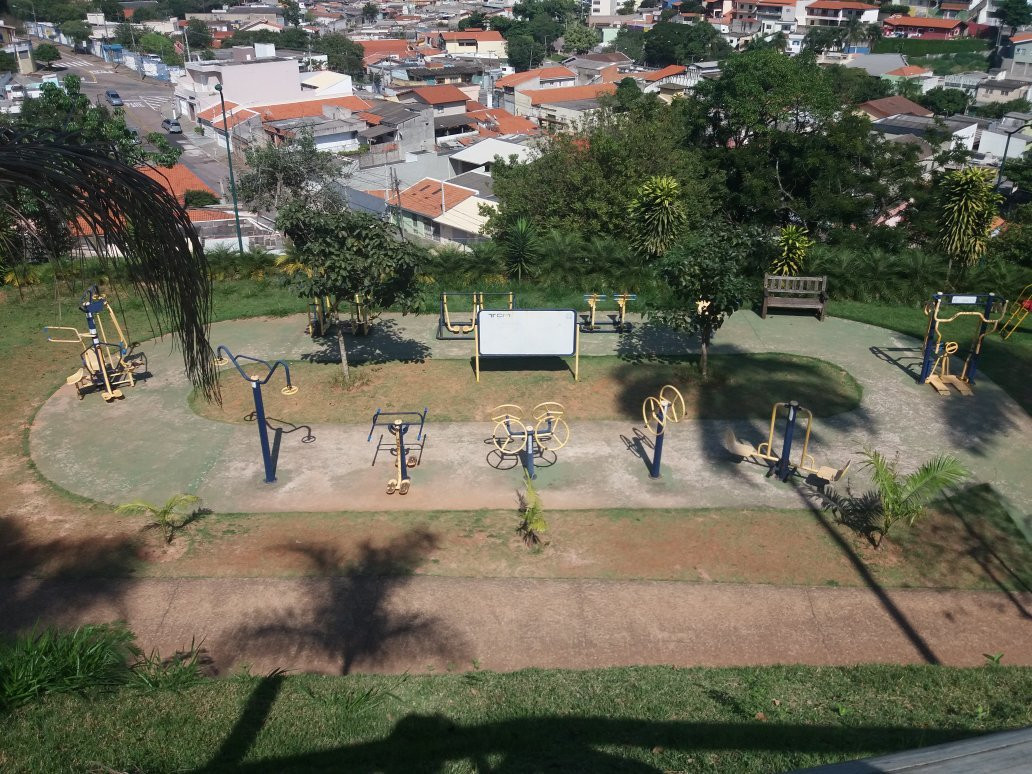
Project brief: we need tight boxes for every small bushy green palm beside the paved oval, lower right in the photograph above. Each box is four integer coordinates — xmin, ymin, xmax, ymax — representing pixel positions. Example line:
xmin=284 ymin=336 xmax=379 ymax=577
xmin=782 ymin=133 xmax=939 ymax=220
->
xmin=825 ymin=448 xmax=969 ymax=547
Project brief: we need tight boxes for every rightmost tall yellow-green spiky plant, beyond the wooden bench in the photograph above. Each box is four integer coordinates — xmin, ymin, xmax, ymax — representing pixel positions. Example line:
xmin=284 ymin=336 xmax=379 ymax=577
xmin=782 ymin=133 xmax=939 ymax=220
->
xmin=939 ymin=166 xmax=1003 ymax=281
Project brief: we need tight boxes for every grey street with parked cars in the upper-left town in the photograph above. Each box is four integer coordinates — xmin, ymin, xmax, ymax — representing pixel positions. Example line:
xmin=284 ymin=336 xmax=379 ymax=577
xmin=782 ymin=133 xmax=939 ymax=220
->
xmin=56 ymin=46 xmax=229 ymax=196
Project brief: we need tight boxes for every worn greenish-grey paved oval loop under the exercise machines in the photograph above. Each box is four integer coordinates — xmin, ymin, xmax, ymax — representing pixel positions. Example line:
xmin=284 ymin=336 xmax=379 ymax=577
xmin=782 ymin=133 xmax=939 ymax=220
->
xmin=30 ymin=312 xmax=1032 ymax=534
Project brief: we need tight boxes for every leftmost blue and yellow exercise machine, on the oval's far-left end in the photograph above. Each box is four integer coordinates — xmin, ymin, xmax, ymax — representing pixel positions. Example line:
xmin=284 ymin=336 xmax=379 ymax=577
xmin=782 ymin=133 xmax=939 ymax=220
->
xmin=43 ymin=285 xmax=136 ymax=402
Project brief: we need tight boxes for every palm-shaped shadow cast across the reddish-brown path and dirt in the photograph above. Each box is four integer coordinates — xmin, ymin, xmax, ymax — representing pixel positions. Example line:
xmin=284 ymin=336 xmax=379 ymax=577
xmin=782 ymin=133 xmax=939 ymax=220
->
xmin=220 ymin=529 xmax=470 ymax=675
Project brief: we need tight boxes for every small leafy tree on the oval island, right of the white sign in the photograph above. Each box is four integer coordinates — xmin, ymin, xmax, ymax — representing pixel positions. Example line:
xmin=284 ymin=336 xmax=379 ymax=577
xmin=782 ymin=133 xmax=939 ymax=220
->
xmin=654 ymin=229 xmax=753 ymax=379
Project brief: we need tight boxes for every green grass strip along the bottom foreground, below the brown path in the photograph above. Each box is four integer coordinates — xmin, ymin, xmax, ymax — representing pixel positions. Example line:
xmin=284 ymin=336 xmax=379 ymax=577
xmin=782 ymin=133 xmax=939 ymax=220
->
xmin=0 ymin=654 xmax=1032 ymax=774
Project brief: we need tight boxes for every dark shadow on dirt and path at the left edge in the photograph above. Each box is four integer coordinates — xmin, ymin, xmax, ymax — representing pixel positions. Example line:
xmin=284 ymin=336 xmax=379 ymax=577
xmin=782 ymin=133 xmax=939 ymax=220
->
xmin=0 ymin=516 xmax=140 ymax=634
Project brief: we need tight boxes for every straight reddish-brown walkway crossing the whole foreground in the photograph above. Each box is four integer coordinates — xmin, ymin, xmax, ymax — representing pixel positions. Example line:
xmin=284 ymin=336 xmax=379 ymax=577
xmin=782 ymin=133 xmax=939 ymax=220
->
xmin=0 ymin=576 xmax=1032 ymax=673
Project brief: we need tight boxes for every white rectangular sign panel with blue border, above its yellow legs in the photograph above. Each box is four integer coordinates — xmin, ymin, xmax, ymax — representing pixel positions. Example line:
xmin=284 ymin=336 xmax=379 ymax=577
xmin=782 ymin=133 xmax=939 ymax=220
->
xmin=477 ymin=309 xmax=578 ymax=357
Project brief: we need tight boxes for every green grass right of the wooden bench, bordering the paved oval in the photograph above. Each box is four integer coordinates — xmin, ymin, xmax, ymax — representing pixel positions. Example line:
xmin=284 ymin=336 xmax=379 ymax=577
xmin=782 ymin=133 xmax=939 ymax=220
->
xmin=828 ymin=300 xmax=1032 ymax=414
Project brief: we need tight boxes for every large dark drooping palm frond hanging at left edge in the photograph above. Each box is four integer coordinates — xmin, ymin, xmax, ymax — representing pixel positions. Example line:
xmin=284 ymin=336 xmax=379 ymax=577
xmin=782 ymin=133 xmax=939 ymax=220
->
xmin=0 ymin=127 xmax=219 ymax=399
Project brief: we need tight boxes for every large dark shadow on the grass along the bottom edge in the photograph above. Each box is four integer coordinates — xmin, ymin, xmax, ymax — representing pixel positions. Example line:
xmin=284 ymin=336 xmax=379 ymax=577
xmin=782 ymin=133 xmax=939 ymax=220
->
xmin=201 ymin=714 xmax=986 ymax=774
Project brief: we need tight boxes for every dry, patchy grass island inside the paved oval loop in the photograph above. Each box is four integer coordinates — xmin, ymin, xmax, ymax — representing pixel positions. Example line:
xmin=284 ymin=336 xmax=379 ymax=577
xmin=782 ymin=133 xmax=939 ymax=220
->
xmin=190 ymin=353 xmax=861 ymax=424
